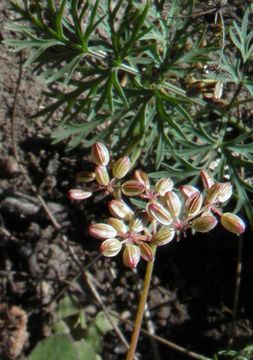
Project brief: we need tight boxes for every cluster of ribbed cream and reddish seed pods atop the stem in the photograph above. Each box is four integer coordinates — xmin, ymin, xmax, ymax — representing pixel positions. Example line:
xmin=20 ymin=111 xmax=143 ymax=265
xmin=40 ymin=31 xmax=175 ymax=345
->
xmin=69 ymin=143 xmax=245 ymax=268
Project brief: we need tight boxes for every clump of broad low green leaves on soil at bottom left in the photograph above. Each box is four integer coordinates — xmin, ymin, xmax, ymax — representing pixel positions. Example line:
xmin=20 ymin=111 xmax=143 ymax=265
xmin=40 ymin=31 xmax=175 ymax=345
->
xmin=28 ymin=296 xmax=117 ymax=360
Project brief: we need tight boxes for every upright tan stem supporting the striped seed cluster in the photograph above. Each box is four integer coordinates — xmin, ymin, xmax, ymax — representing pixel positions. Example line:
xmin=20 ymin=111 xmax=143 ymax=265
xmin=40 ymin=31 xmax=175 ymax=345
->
xmin=126 ymin=246 xmax=156 ymax=360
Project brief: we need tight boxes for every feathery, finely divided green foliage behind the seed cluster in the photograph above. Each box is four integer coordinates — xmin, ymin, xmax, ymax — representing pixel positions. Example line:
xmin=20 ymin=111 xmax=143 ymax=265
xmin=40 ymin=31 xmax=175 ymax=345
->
xmin=5 ymin=0 xmax=253 ymax=225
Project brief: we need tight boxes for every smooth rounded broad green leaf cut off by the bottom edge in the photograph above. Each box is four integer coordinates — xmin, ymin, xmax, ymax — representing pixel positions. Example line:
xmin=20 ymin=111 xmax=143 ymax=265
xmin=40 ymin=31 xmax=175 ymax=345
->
xmin=28 ymin=335 xmax=78 ymax=360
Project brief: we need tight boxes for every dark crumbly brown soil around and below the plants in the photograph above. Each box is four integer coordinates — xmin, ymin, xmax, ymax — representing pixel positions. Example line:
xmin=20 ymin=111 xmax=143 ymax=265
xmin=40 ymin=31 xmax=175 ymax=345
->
xmin=0 ymin=1 xmax=253 ymax=360
